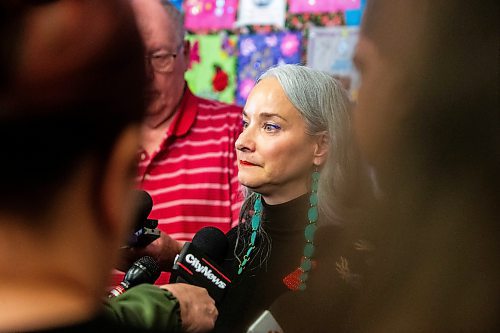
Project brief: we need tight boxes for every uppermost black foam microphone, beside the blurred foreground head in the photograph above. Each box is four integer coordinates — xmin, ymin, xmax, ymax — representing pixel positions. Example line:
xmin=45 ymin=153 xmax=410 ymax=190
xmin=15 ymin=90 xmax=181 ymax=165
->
xmin=128 ymin=190 xmax=160 ymax=247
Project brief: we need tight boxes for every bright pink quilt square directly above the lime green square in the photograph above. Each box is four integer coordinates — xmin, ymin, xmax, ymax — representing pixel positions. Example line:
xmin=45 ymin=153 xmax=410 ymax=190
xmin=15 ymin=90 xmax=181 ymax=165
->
xmin=184 ymin=0 xmax=238 ymax=31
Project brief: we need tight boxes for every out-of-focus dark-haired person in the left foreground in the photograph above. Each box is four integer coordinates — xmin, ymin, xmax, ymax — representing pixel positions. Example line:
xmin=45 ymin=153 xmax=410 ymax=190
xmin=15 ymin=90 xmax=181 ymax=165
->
xmin=0 ymin=0 xmax=217 ymax=332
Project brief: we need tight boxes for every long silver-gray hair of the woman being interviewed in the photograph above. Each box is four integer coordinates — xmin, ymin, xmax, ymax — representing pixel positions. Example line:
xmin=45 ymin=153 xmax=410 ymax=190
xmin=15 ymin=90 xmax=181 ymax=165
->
xmin=234 ymin=65 xmax=364 ymax=270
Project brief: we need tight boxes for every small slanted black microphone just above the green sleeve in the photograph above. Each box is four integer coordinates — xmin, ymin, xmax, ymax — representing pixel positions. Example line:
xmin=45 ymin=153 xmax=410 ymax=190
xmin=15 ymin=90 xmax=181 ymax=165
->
xmin=108 ymin=256 xmax=161 ymax=298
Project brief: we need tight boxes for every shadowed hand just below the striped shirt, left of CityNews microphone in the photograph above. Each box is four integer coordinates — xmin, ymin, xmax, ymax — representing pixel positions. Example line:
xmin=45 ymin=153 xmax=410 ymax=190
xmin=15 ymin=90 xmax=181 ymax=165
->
xmin=117 ymin=232 xmax=185 ymax=272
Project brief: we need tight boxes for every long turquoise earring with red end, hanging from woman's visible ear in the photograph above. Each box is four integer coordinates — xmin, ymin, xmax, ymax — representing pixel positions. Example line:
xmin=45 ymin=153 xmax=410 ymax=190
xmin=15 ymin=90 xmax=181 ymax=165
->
xmin=283 ymin=166 xmax=319 ymax=291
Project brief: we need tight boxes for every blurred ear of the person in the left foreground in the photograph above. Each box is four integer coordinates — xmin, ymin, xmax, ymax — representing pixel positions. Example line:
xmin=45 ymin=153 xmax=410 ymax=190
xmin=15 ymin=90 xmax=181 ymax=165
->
xmin=100 ymin=126 xmax=140 ymax=246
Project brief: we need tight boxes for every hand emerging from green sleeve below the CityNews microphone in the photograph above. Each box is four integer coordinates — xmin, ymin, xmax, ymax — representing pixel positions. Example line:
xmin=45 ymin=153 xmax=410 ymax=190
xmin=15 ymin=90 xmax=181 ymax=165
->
xmin=161 ymin=283 xmax=219 ymax=333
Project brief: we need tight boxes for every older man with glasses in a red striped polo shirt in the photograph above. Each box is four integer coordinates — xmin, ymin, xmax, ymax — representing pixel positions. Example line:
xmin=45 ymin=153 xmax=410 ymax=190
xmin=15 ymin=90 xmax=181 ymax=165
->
xmin=124 ymin=0 xmax=242 ymax=283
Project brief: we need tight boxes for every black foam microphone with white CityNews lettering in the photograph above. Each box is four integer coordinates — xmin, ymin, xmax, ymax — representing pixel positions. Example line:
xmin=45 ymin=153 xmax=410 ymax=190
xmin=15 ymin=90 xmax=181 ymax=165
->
xmin=170 ymin=227 xmax=231 ymax=303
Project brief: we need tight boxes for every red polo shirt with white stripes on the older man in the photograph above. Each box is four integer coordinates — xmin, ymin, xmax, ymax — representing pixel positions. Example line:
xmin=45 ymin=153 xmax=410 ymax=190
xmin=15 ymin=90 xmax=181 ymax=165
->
xmin=139 ymin=88 xmax=243 ymax=241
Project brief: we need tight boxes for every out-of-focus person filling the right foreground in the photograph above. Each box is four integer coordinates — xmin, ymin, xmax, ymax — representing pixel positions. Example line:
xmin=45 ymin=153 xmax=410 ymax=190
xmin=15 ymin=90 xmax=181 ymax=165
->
xmin=273 ymin=0 xmax=500 ymax=333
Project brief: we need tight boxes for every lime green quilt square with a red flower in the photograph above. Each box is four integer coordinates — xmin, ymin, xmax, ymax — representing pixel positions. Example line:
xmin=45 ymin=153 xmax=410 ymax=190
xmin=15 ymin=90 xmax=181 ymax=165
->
xmin=185 ymin=34 xmax=237 ymax=103
